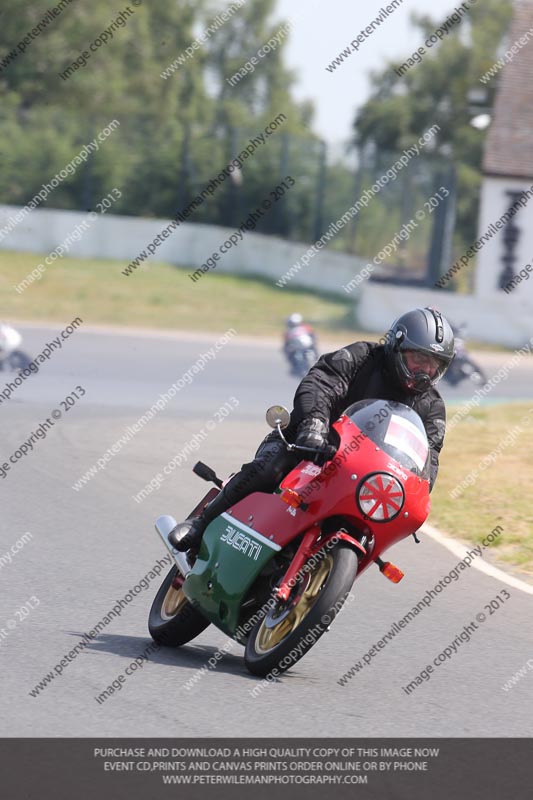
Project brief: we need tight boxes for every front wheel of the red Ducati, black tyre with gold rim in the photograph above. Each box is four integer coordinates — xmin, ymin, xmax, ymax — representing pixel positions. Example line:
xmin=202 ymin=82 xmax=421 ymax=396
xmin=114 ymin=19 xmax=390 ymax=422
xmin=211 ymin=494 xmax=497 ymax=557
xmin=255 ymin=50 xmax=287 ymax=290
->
xmin=244 ymin=543 xmax=358 ymax=675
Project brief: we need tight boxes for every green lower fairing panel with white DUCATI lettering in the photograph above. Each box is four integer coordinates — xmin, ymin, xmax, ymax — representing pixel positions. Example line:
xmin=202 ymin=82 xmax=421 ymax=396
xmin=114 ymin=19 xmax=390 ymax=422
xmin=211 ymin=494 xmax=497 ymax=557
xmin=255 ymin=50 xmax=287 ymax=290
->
xmin=183 ymin=514 xmax=281 ymax=636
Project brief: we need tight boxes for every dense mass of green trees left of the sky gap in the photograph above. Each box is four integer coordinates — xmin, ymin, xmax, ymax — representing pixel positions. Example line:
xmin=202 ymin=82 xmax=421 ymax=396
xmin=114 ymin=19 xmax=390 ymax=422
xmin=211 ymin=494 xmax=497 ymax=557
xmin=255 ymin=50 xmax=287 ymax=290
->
xmin=0 ymin=0 xmax=332 ymax=244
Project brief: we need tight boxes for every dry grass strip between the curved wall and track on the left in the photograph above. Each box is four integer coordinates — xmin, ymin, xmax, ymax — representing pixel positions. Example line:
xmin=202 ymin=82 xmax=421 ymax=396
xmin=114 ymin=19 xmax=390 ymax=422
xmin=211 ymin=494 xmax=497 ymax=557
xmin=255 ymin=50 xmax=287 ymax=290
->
xmin=0 ymin=251 xmax=370 ymax=344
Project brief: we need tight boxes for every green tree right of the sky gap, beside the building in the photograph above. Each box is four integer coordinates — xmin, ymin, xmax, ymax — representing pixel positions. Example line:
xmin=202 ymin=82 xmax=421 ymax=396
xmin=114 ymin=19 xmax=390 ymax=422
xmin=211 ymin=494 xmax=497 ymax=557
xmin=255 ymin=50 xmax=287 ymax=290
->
xmin=354 ymin=0 xmax=512 ymax=243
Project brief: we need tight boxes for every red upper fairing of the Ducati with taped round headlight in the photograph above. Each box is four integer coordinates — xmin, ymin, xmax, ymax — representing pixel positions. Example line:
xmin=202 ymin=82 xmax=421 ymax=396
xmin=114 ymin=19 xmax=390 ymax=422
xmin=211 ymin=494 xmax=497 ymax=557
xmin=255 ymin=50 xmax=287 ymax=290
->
xmin=230 ymin=409 xmax=430 ymax=573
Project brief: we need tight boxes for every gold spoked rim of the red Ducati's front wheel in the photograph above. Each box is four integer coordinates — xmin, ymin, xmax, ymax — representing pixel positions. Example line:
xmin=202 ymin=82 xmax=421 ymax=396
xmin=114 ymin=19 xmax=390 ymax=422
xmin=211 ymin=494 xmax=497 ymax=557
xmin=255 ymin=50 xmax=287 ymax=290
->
xmin=255 ymin=555 xmax=333 ymax=653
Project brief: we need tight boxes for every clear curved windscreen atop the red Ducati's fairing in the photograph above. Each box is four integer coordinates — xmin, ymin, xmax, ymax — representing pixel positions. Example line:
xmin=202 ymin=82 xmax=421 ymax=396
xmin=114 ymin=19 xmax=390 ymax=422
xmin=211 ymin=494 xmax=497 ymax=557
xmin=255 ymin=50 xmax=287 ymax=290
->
xmin=344 ymin=400 xmax=430 ymax=480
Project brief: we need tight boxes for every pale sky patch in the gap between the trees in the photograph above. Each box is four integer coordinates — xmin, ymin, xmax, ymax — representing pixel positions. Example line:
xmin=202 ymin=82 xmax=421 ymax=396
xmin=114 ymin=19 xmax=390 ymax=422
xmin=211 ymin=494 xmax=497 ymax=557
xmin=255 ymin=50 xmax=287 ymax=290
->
xmin=276 ymin=0 xmax=470 ymax=144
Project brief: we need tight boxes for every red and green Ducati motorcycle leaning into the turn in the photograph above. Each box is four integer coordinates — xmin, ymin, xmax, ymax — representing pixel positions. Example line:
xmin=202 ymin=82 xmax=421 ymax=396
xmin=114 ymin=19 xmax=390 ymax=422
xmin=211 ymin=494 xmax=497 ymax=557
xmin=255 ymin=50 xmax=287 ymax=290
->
xmin=149 ymin=400 xmax=430 ymax=675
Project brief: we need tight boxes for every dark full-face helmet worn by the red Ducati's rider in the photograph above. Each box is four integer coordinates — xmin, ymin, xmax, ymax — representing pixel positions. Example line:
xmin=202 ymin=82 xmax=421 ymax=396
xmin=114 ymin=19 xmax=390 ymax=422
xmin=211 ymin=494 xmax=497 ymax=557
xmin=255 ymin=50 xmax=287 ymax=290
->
xmin=385 ymin=308 xmax=455 ymax=393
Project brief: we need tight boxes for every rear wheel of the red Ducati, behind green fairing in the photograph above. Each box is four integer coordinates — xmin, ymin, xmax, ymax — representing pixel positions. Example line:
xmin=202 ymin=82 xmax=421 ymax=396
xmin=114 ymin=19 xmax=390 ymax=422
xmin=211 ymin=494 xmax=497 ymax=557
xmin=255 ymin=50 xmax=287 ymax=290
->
xmin=148 ymin=566 xmax=209 ymax=647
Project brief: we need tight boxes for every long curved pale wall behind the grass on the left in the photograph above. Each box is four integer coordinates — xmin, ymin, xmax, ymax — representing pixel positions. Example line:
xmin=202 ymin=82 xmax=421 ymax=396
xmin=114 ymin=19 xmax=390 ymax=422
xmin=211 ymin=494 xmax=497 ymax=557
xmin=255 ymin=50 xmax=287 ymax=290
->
xmin=0 ymin=206 xmax=366 ymax=298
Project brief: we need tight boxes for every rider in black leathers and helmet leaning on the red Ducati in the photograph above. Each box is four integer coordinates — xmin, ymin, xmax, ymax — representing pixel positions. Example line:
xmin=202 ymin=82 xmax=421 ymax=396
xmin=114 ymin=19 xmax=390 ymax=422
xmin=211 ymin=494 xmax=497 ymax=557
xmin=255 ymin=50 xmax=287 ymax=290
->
xmin=168 ymin=308 xmax=455 ymax=552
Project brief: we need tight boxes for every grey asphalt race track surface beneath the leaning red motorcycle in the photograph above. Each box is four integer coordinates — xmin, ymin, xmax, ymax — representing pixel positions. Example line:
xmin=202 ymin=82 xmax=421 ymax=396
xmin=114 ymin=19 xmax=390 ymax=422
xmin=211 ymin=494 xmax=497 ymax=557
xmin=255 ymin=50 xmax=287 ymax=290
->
xmin=0 ymin=326 xmax=533 ymax=737
